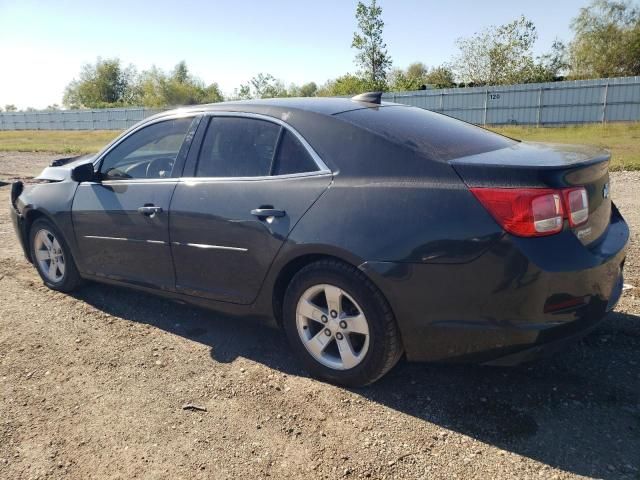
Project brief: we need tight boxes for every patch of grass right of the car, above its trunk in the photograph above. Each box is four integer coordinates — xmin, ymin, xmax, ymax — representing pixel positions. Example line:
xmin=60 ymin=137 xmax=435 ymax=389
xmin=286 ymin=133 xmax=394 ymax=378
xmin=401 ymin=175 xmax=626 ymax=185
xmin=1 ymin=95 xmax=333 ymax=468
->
xmin=491 ymin=122 xmax=640 ymax=170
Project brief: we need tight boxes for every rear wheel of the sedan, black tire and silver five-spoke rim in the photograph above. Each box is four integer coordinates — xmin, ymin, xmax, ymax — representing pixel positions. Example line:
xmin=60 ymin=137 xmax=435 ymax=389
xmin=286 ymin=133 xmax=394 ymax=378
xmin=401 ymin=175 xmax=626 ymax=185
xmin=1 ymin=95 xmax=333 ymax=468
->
xmin=282 ymin=260 xmax=403 ymax=387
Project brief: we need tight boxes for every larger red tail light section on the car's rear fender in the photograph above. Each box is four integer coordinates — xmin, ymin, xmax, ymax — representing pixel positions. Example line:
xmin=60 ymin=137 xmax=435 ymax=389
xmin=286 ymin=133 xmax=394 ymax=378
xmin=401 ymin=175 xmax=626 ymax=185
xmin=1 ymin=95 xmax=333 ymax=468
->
xmin=471 ymin=188 xmax=564 ymax=237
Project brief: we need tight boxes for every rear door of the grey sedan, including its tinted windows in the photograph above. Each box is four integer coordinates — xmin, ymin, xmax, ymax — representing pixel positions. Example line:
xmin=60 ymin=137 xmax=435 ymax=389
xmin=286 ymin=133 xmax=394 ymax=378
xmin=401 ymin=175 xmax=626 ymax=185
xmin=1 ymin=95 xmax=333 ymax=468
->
xmin=170 ymin=114 xmax=332 ymax=304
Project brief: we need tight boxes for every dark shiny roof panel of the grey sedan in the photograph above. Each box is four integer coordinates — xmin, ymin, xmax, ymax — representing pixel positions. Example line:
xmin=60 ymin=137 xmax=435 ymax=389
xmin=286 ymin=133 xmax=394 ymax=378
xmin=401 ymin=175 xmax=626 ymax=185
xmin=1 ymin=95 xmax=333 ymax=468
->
xmin=151 ymin=97 xmax=399 ymax=116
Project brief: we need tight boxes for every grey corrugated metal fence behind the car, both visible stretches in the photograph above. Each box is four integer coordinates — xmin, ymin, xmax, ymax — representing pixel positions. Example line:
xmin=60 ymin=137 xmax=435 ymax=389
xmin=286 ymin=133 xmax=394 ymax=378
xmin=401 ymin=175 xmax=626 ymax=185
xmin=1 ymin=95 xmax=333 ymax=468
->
xmin=0 ymin=77 xmax=640 ymax=130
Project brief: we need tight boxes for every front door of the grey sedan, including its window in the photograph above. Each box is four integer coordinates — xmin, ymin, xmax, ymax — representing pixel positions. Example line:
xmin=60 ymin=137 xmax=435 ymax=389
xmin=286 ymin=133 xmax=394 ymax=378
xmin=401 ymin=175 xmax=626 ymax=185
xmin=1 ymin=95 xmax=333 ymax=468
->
xmin=72 ymin=116 xmax=197 ymax=290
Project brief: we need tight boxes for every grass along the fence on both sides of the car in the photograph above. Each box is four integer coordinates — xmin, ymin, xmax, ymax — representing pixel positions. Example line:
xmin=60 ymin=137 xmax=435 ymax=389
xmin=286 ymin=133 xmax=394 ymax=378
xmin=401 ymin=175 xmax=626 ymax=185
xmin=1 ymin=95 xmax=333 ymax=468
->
xmin=0 ymin=122 xmax=640 ymax=170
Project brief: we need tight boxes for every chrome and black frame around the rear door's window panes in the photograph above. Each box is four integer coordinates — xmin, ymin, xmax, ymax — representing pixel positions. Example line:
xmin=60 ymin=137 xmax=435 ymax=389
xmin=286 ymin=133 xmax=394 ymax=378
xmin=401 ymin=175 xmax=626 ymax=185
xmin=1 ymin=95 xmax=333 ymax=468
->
xmin=189 ymin=111 xmax=333 ymax=181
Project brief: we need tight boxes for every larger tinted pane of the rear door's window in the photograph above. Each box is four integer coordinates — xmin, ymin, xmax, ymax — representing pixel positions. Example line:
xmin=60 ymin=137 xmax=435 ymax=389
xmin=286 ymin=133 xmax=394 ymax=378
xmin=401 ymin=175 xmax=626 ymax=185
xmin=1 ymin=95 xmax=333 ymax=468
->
xmin=196 ymin=117 xmax=280 ymax=177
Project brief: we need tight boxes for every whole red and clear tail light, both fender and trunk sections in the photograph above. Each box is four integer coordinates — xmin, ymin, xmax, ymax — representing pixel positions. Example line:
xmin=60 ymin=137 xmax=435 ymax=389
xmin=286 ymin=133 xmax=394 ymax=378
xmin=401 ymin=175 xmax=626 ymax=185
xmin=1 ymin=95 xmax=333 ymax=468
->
xmin=471 ymin=187 xmax=589 ymax=237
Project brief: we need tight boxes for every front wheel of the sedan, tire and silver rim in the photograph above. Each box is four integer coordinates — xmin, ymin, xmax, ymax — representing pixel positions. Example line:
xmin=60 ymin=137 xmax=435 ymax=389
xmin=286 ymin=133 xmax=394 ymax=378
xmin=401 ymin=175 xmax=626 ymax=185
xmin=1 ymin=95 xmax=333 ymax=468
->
xmin=29 ymin=218 xmax=82 ymax=293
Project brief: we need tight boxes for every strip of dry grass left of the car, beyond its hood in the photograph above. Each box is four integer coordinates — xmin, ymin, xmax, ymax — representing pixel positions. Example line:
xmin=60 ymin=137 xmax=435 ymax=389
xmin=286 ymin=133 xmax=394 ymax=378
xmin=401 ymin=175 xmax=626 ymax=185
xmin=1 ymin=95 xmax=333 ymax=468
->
xmin=0 ymin=130 xmax=120 ymax=154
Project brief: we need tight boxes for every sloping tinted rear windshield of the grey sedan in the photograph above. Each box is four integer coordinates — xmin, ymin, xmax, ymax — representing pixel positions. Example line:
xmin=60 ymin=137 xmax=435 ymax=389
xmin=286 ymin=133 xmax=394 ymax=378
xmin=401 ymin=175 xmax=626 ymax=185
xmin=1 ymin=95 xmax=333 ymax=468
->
xmin=337 ymin=106 xmax=515 ymax=161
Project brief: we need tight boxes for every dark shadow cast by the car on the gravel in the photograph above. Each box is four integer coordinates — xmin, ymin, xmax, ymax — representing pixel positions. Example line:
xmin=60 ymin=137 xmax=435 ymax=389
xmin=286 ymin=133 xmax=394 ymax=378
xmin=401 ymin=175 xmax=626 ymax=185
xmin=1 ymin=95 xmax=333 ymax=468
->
xmin=76 ymin=285 xmax=640 ymax=479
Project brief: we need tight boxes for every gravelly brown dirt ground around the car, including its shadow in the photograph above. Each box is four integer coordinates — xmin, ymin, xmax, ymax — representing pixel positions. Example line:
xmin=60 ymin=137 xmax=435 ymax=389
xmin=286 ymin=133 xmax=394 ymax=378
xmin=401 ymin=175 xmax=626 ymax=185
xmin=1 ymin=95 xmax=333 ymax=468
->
xmin=0 ymin=152 xmax=640 ymax=480
